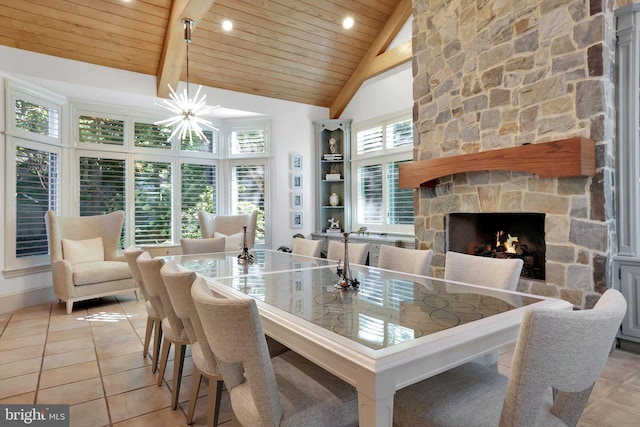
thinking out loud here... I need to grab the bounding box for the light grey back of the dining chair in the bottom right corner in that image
[500,289,627,426]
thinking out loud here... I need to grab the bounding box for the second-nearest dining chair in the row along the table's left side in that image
[160,261,224,427]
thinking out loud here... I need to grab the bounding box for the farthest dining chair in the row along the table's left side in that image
[124,246,165,372]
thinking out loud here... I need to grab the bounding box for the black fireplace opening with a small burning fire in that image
[447,213,546,280]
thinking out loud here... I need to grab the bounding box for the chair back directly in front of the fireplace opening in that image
[444,251,524,291]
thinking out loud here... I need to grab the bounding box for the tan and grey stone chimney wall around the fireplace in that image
[413,0,616,307]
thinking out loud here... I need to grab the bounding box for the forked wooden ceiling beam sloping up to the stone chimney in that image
[329,0,412,119]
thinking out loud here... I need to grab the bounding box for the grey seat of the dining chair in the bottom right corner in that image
[393,362,562,427]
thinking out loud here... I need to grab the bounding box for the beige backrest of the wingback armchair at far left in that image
[44,210,124,262]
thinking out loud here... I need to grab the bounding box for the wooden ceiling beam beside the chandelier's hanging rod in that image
[156,0,215,98]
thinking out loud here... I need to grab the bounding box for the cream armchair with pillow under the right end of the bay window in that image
[198,210,258,251]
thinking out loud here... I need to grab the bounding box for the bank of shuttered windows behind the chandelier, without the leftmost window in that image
[74,104,268,245]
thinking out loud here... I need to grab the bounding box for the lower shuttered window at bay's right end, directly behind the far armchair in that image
[231,164,266,242]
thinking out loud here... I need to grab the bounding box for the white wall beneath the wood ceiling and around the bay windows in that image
[0,17,413,313]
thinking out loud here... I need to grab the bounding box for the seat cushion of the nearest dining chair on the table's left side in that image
[231,351,358,427]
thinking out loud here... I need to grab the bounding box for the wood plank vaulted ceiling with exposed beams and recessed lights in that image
[0,0,411,117]
